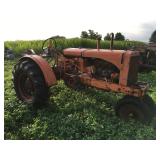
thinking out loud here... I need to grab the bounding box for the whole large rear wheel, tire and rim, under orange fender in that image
[13,60,49,104]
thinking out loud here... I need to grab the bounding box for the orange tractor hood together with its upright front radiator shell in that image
[64,48,139,86]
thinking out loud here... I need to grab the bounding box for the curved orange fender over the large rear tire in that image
[19,55,57,87]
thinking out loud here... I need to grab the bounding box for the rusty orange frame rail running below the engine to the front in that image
[64,73,149,97]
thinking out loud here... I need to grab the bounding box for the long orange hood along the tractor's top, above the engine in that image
[63,48,139,74]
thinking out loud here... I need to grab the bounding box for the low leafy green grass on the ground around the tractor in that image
[4,60,156,140]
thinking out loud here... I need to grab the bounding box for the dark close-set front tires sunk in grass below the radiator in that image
[115,95,154,122]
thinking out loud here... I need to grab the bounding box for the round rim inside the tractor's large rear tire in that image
[18,74,34,102]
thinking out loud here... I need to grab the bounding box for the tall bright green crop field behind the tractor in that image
[4,38,145,56]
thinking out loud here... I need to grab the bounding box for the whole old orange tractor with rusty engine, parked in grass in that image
[13,36,156,122]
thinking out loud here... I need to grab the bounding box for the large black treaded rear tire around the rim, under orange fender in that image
[12,60,49,105]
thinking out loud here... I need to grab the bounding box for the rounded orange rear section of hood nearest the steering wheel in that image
[63,48,87,57]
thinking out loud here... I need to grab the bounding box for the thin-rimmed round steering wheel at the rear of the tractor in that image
[42,37,57,56]
